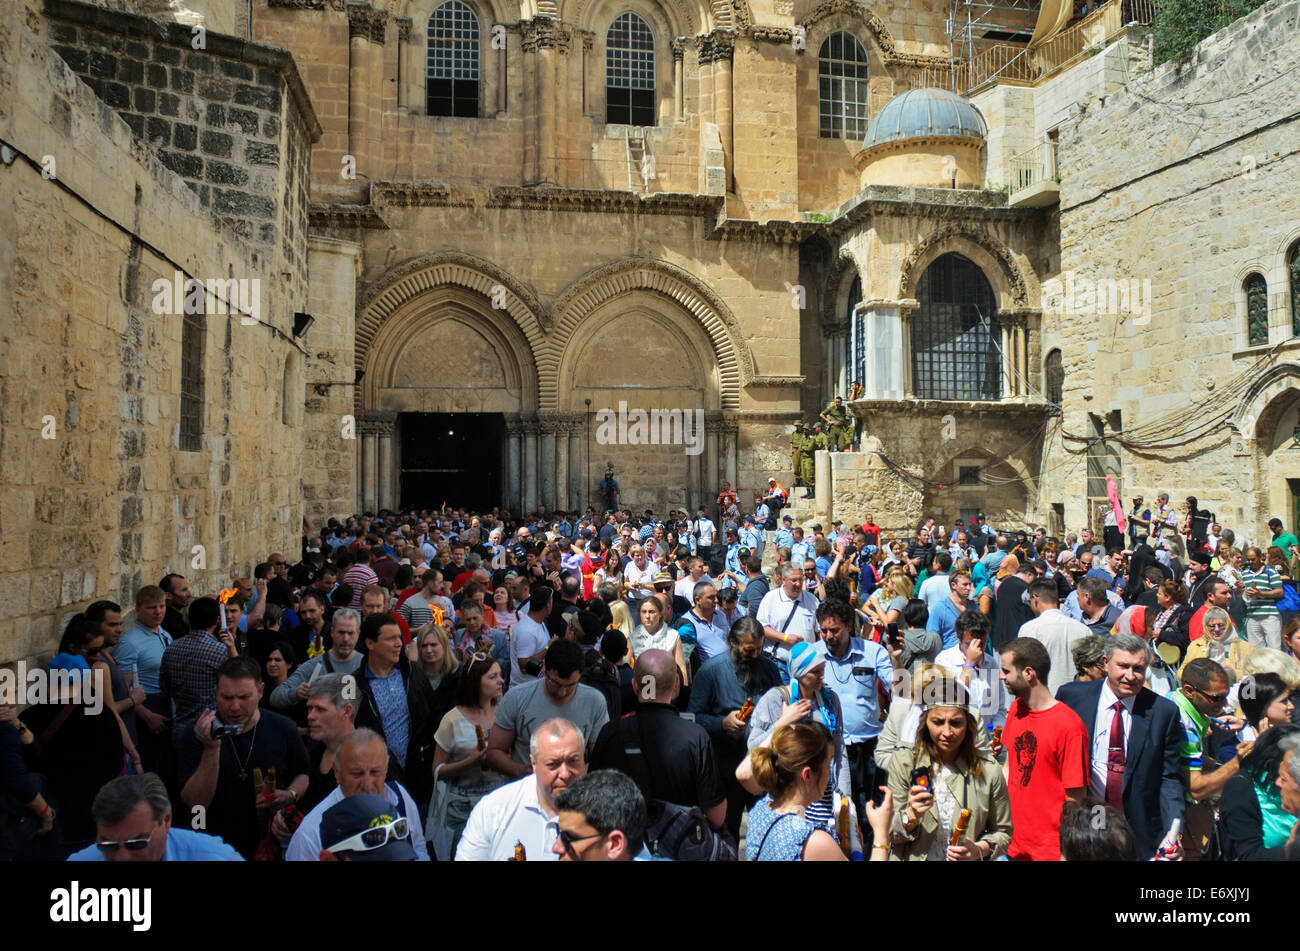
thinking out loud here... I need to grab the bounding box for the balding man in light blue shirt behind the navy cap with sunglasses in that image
[285,729,429,861]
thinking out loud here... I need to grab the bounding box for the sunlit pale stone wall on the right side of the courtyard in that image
[1041,0,1300,539]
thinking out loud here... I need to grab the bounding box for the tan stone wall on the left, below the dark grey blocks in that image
[0,4,306,663]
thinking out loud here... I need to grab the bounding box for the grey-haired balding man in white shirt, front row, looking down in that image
[452,717,586,861]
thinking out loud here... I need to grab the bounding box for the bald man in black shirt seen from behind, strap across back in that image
[592,650,727,829]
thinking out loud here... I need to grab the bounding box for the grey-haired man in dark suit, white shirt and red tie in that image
[1057,634,1184,859]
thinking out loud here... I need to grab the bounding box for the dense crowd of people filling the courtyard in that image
[0,491,1300,861]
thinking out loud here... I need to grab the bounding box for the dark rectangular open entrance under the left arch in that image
[398,413,506,511]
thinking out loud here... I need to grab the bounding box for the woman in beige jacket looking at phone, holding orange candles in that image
[888,678,1011,861]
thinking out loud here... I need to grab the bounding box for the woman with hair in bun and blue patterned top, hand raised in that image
[745,722,893,861]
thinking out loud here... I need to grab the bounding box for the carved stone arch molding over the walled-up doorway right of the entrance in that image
[537,257,754,409]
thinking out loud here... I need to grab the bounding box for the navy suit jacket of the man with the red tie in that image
[1057,681,1184,860]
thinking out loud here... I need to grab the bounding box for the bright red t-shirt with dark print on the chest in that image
[1002,698,1089,861]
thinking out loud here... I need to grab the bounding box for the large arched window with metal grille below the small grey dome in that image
[911,253,1002,400]
